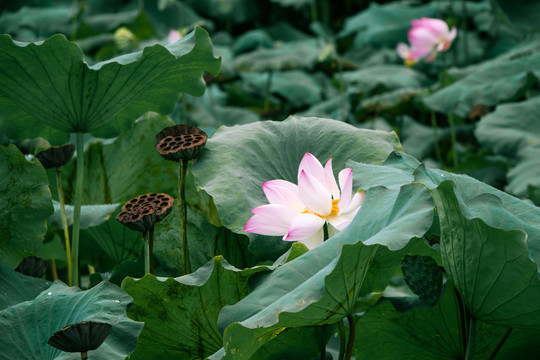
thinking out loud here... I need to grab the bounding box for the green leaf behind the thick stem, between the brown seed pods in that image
[58,113,178,204]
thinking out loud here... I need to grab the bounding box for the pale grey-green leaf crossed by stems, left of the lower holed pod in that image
[49,200,120,229]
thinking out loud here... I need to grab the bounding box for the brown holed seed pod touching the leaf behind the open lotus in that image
[156,125,208,161]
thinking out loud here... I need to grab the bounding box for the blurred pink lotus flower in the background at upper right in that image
[397,18,457,65]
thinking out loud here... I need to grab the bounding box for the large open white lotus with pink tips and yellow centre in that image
[244,153,365,249]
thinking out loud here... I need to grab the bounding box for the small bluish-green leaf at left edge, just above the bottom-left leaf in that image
[0,263,51,311]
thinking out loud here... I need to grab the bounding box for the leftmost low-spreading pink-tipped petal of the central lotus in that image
[244,204,298,236]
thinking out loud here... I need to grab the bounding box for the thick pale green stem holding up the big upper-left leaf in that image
[71,132,84,286]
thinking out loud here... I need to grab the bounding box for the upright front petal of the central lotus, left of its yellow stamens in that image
[298,170,332,216]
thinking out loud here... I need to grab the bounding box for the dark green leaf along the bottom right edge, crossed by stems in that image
[353,282,540,360]
